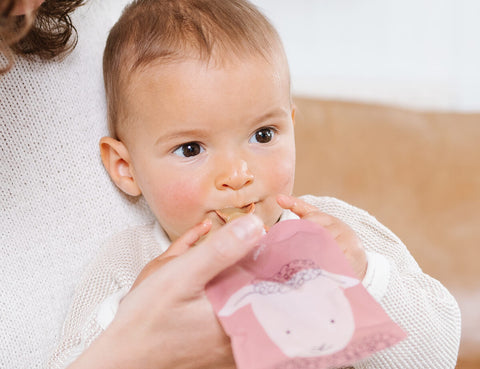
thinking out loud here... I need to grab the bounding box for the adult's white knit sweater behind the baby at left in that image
[0,0,152,369]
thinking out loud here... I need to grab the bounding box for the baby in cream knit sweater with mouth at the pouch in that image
[48,0,460,368]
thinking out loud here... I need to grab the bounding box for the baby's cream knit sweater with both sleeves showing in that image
[49,196,460,369]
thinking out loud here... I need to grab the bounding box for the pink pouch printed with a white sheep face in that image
[206,220,406,369]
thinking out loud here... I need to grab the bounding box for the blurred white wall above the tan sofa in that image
[253,0,480,111]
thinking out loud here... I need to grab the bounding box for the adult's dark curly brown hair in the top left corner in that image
[0,0,85,74]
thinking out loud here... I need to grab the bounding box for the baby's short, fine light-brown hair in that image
[103,0,284,137]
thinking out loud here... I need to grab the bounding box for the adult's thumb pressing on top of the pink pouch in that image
[173,215,264,290]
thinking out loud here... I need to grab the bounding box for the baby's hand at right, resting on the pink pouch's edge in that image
[277,195,367,280]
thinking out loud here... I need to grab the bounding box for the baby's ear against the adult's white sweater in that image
[100,137,142,196]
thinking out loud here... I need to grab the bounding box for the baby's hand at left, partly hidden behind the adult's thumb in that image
[131,219,212,290]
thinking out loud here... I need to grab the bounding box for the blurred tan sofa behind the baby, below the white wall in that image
[295,98,480,369]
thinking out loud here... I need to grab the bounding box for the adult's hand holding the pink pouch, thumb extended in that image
[70,215,263,369]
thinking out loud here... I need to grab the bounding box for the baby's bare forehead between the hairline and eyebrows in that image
[119,51,291,137]
